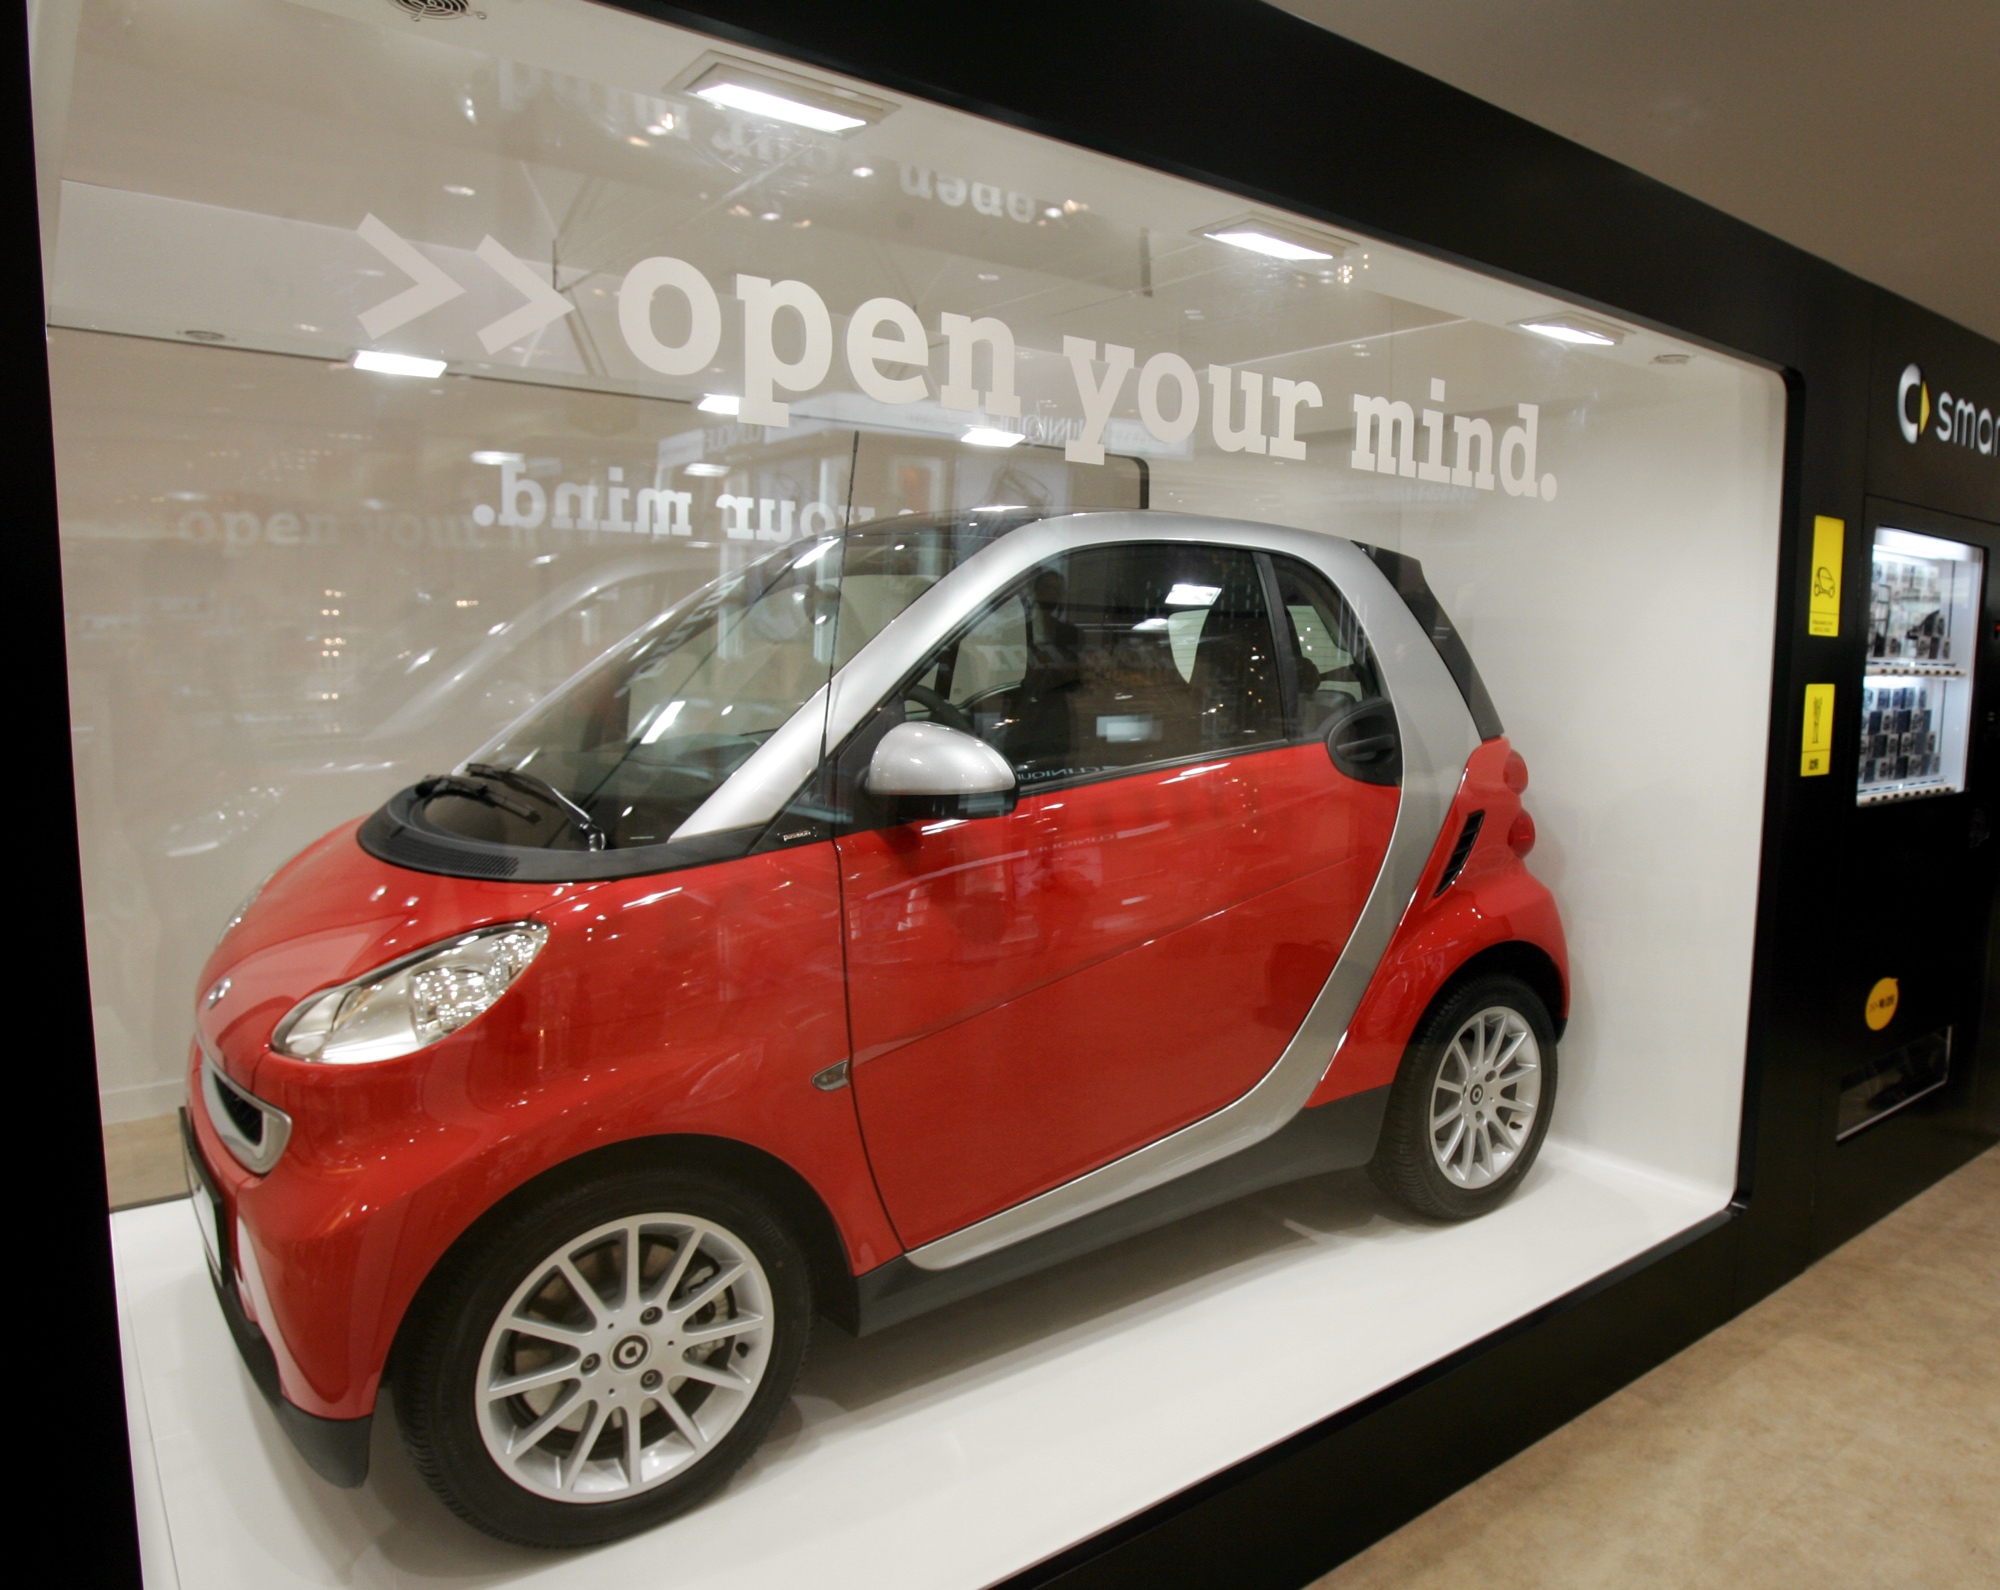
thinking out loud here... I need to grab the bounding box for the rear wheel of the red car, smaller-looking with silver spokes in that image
[1368,974,1556,1220]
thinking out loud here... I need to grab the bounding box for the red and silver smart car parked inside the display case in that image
[188,510,1566,1546]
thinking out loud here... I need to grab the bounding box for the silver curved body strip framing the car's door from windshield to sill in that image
[676,510,1480,1270]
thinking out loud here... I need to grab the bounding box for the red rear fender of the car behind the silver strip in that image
[1306,736,1570,1108]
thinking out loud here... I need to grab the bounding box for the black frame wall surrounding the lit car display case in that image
[27,0,2000,1590]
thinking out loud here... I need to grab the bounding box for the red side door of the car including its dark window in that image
[838,542,1396,1246]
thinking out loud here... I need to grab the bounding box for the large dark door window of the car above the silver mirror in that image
[904,544,1284,792]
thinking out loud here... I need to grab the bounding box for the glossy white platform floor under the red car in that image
[112,1142,1728,1590]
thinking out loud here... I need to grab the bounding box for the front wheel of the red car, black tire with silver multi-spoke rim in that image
[394,1170,814,1548]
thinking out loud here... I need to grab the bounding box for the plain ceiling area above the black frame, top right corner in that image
[1278,0,2000,338]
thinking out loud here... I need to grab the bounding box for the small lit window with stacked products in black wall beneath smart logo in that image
[1856,526,1986,806]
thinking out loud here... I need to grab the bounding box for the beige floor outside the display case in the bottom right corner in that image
[1312,1150,2000,1590]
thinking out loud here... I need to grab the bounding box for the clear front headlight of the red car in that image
[270,922,548,1066]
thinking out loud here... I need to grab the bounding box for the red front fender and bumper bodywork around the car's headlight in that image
[194,834,900,1418]
